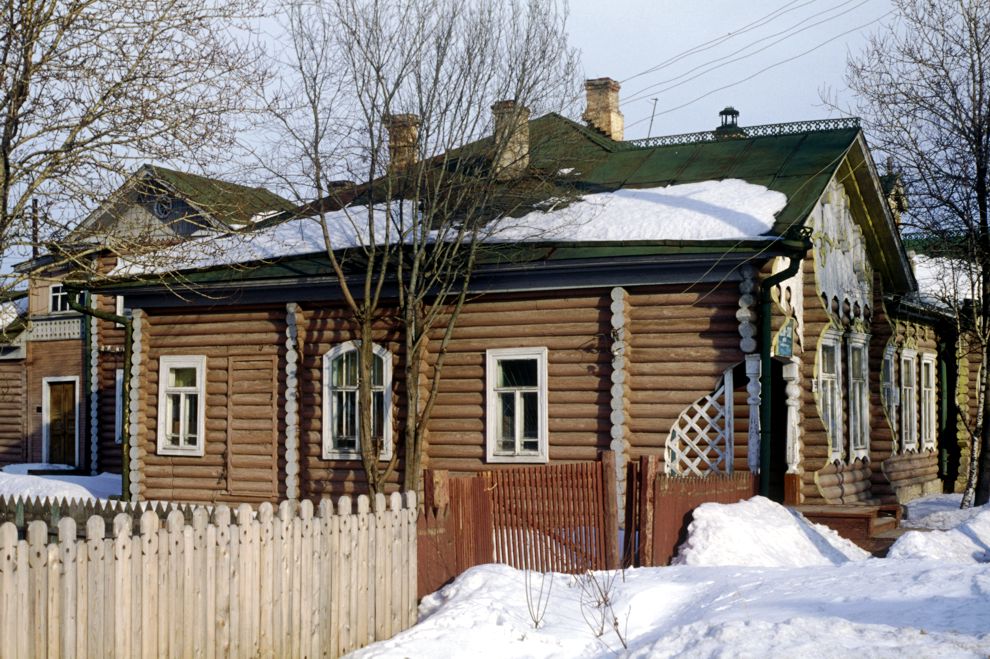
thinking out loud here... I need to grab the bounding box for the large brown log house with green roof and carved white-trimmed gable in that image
[104,79,964,504]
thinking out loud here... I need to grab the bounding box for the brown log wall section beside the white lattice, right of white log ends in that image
[627,282,748,469]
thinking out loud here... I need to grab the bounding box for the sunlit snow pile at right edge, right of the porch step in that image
[887,510,990,563]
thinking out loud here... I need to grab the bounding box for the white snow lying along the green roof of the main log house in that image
[112,179,787,276]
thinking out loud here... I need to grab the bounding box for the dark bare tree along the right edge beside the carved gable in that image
[847,0,990,504]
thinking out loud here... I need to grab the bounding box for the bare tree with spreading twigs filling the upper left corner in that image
[0,0,263,288]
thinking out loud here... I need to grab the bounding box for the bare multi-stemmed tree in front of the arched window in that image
[268,0,578,492]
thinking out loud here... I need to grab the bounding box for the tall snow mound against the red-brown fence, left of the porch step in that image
[674,497,869,567]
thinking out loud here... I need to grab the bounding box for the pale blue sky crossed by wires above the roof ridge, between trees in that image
[569,0,891,139]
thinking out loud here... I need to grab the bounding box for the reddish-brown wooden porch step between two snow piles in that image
[791,504,902,556]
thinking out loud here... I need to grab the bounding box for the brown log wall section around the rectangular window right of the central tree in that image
[424,289,612,475]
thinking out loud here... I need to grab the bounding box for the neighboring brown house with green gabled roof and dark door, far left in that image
[0,165,292,472]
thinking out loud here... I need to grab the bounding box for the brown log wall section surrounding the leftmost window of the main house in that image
[139,307,285,502]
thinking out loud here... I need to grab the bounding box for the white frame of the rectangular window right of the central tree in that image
[485,347,550,464]
